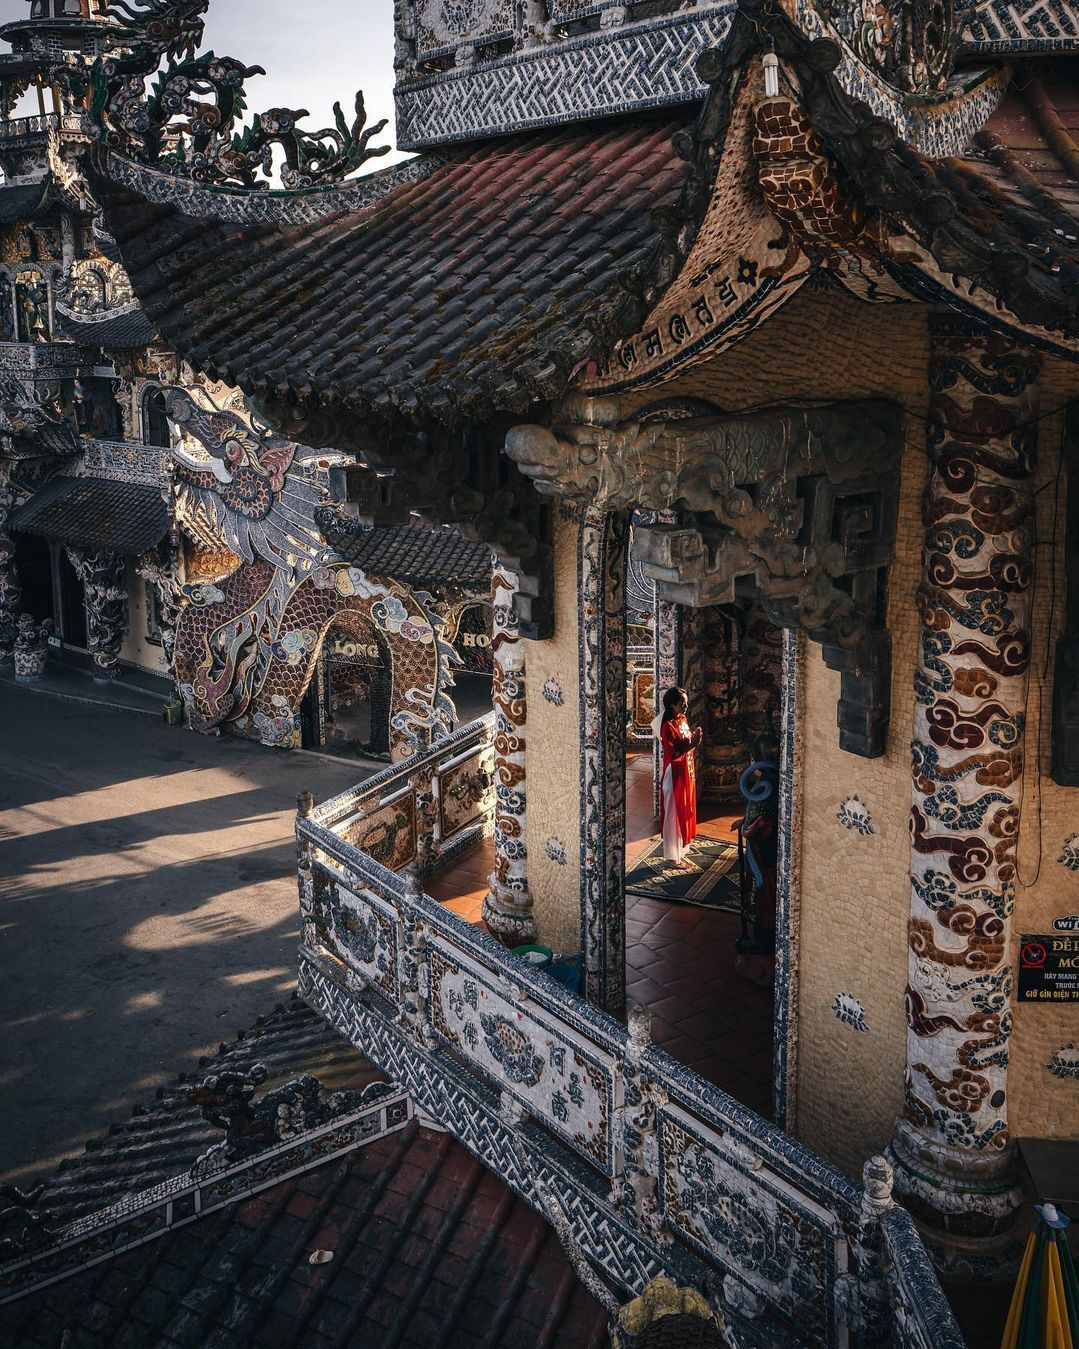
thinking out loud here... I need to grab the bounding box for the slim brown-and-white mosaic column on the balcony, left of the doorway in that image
[483,565,537,946]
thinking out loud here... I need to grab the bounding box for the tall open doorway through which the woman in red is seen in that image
[626,603,782,1116]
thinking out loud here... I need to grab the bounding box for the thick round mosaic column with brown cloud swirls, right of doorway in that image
[892,317,1039,1272]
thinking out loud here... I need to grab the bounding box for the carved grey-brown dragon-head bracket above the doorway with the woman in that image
[506,399,902,757]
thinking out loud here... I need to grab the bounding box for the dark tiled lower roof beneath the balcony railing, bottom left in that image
[0,998,608,1349]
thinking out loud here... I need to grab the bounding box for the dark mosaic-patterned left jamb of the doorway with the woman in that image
[577,506,630,1016]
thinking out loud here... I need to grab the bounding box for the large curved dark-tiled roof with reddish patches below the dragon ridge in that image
[97,109,696,417]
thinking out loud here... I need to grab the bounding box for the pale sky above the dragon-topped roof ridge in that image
[0,0,402,169]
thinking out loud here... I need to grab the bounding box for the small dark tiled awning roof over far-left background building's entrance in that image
[8,475,169,556]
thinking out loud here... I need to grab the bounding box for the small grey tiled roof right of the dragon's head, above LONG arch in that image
[316,507,492,590]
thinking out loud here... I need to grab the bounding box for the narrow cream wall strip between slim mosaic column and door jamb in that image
[525,507,580,954]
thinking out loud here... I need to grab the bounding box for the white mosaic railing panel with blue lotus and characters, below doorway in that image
[430,951,615,1174]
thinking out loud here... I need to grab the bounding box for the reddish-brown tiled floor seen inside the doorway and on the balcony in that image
[428,753,771,1116]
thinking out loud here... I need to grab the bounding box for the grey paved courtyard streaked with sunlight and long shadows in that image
[0,685,368,1183]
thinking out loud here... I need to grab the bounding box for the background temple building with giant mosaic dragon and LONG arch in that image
[0,3,491,758]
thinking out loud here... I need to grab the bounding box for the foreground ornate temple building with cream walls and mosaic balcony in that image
[5,0,1079,1349]
